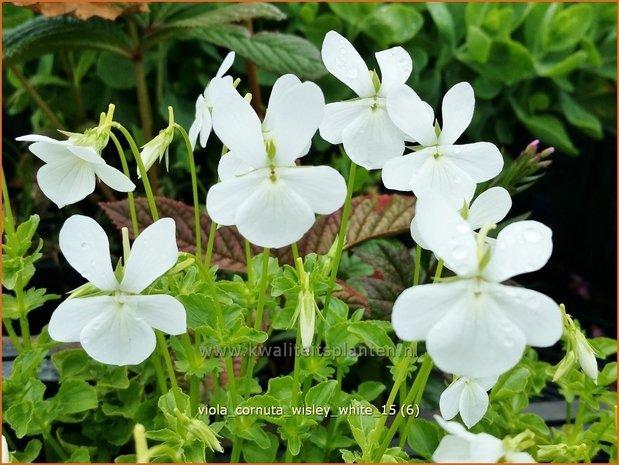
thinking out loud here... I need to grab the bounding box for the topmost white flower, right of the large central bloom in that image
[320,31,413,169]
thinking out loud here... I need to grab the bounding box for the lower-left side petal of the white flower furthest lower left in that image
[48,295,115,342]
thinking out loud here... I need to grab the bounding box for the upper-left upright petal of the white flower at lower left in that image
[58,215,118,291]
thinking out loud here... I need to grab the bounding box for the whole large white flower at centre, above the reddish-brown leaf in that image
[206,74,346,248]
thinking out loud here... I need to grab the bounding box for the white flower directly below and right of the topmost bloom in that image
[382,82,503,202]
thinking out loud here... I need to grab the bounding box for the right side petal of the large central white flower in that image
[277,166,346,215]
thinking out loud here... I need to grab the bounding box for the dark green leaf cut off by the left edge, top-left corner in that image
[3,16,130,64]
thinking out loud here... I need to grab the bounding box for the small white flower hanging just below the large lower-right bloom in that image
[439,376,498,428]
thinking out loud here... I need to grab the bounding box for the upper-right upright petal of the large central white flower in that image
[264,75,325,166]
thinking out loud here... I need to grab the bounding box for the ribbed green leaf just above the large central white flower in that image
[194,25,326,79]
